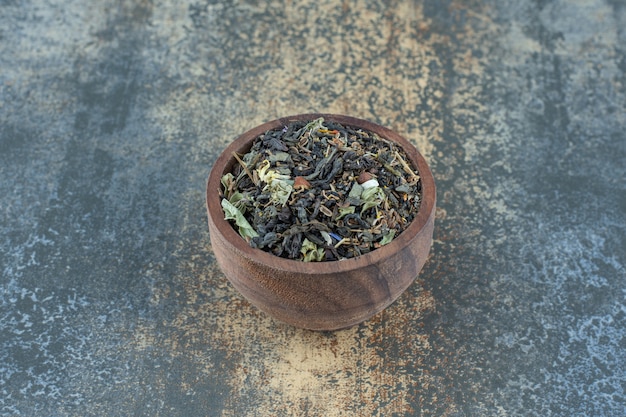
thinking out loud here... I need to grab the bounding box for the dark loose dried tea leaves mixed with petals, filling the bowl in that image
[221,118,421,261]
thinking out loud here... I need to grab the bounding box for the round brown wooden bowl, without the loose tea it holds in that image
[206,114,436,330]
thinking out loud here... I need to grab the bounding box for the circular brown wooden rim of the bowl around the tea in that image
[206,113,437,275]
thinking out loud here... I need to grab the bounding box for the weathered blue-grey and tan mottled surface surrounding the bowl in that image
[0,0,626,417]
